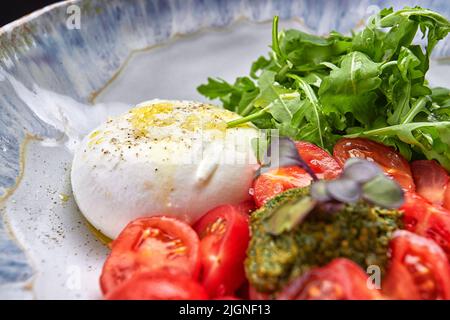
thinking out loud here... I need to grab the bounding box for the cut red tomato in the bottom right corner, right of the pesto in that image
[383,230,450,300]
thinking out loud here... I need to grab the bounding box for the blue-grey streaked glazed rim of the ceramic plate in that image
[0,0,450,292]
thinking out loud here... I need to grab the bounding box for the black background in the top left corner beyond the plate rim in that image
[0,0,59,26]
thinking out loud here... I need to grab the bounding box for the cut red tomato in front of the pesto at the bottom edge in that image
[277,258,382,300]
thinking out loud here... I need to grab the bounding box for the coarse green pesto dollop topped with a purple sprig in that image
[245,188,401,292]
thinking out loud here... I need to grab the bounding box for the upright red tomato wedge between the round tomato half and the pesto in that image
[194,205,250,297]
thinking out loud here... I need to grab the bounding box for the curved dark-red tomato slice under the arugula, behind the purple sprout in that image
[333,138,415,191]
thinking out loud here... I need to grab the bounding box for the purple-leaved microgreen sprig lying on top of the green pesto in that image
[266,149,404,235]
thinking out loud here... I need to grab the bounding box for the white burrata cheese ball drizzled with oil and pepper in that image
[71,100,258,238]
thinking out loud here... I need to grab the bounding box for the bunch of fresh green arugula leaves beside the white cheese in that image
[198,7,450,170]
